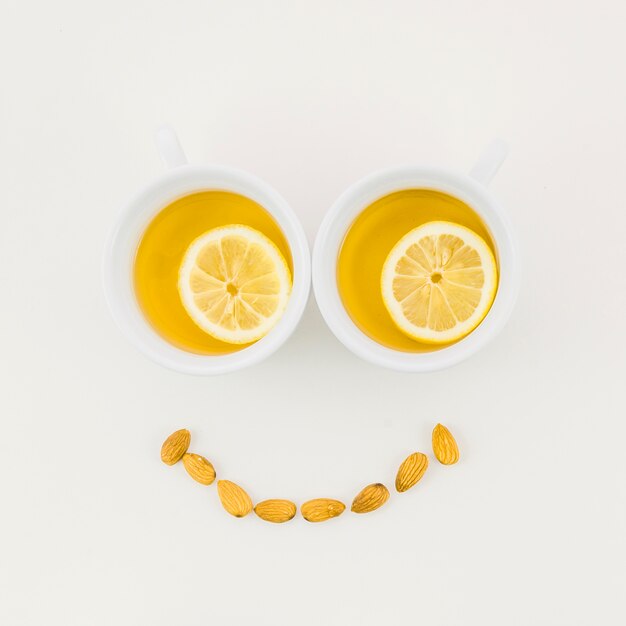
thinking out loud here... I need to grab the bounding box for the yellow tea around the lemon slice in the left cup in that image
[134,191,293,355]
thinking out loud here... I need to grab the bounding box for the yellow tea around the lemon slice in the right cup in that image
[337,189,497,352]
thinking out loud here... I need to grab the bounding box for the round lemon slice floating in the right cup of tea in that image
[381,222,498,343]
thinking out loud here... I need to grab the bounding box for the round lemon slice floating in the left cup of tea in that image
[178,224,291,344]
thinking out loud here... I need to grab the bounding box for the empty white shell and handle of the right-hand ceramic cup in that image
[313,140,520,372]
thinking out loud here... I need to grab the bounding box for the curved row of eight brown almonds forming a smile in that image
[161,424,459,524]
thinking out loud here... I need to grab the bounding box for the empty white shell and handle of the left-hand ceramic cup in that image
[103,126,311,374]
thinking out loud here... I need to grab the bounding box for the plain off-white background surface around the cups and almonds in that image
[0,0,626,626]
